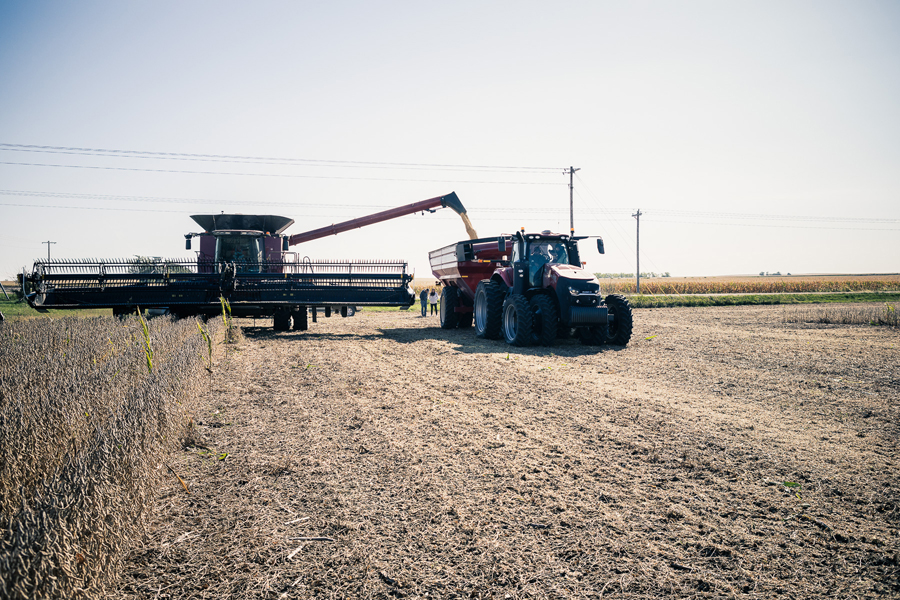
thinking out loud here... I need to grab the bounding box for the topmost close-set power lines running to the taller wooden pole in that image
[0,143,559,173]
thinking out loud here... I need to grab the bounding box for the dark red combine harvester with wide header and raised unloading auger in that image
[21,192,465,331]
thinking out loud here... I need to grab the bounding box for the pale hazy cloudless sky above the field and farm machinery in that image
[0,0,900,277]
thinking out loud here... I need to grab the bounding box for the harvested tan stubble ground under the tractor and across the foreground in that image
[119,307,900,598]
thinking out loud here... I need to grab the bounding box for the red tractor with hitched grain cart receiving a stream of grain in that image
[429,229,632,346]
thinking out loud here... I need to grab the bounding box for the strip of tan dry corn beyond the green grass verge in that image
[600,278,900,294]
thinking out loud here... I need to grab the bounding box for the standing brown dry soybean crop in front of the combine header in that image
[0,317,219,599]
